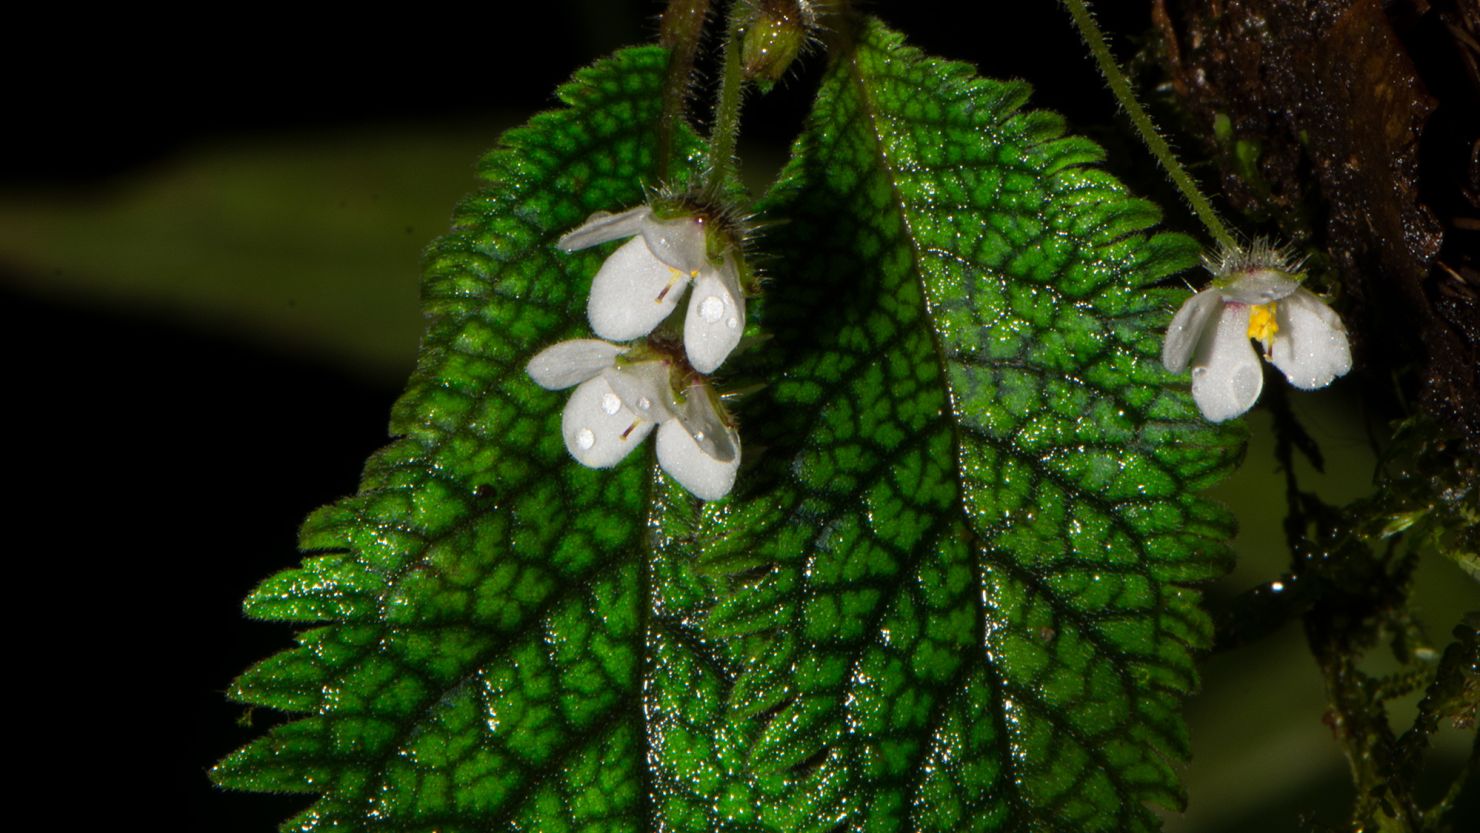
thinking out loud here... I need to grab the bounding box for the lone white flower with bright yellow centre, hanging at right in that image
[1162,268,1351,422]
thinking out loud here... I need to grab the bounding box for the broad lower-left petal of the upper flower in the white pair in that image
[586,237,688,342]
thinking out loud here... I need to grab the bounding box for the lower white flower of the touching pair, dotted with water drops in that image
[525,339,740,500]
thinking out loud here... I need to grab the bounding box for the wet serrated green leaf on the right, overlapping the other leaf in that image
[703,22,1240,832]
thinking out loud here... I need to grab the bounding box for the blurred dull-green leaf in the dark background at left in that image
[0,121,509,383]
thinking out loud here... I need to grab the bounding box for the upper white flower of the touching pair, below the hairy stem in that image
[559,206,744,373]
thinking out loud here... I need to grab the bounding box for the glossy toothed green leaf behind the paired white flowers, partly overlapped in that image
[213,47,764,833]
